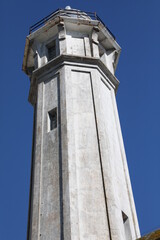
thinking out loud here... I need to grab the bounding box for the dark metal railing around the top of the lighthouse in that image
[29,9,115,39]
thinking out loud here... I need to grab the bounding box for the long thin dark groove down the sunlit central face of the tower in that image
[90,74,112,240]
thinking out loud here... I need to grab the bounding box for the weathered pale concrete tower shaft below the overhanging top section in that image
[27,62,139,240]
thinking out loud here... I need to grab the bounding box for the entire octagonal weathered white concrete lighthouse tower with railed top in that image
[23,7,140,240]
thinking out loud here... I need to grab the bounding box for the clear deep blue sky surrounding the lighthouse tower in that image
[0,0,160,240]
